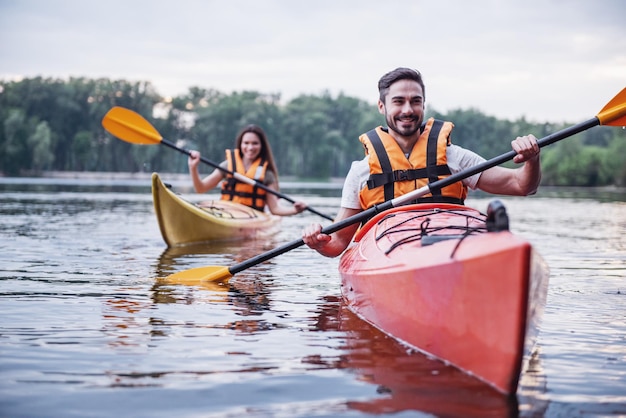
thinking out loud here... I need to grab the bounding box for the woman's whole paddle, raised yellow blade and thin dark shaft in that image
[102,106,333,221]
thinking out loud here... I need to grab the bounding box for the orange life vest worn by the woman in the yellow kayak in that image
[222,150,267,211]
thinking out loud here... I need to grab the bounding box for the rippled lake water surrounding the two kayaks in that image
[0,175,626,417]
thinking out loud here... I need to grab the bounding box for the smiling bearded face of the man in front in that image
[378,80,424,137]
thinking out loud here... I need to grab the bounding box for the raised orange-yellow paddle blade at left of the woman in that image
[102,106,163,145]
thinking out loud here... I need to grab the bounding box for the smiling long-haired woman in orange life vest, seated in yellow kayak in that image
[187,125,306,216]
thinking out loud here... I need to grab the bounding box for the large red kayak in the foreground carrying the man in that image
[339,201,549,394]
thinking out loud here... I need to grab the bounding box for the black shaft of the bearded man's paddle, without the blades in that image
[228,117,600,275]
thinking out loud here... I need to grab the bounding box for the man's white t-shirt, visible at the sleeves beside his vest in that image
[341,144,486,209]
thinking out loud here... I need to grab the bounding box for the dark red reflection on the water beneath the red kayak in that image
[303,297,518,418]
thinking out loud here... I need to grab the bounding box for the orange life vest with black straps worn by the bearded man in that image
[359,118,467,209]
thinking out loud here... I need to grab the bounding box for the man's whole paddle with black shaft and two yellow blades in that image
[169,88,626,281]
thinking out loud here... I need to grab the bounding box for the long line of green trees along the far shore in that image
[0,77,626,186]
